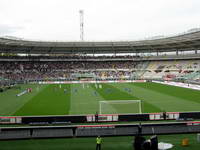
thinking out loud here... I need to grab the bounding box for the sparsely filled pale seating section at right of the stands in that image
[143,60,200,80]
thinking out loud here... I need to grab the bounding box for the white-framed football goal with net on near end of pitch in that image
[99,100,142,114]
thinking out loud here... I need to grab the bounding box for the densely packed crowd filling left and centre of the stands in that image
[0,61,141,80]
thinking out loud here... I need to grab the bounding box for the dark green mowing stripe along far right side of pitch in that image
[134,82,200,103]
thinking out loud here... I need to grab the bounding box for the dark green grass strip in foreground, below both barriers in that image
[0,134,200,150]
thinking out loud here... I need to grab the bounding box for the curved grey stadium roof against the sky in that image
[0,31,200,54]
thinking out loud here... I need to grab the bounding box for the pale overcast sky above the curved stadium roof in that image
[0,0,200,41]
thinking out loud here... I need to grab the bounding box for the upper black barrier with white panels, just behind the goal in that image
[0,112,200,125]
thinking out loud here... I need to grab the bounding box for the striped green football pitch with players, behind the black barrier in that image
[0,82,200,116]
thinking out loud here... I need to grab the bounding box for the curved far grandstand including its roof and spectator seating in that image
[0,30,200,83]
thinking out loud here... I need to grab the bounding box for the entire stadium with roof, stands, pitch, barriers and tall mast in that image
[0,0,200,150]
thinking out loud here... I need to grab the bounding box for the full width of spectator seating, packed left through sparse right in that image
[0,60,200,81]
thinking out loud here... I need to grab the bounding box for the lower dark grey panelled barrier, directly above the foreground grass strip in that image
[0,122,200,140]
